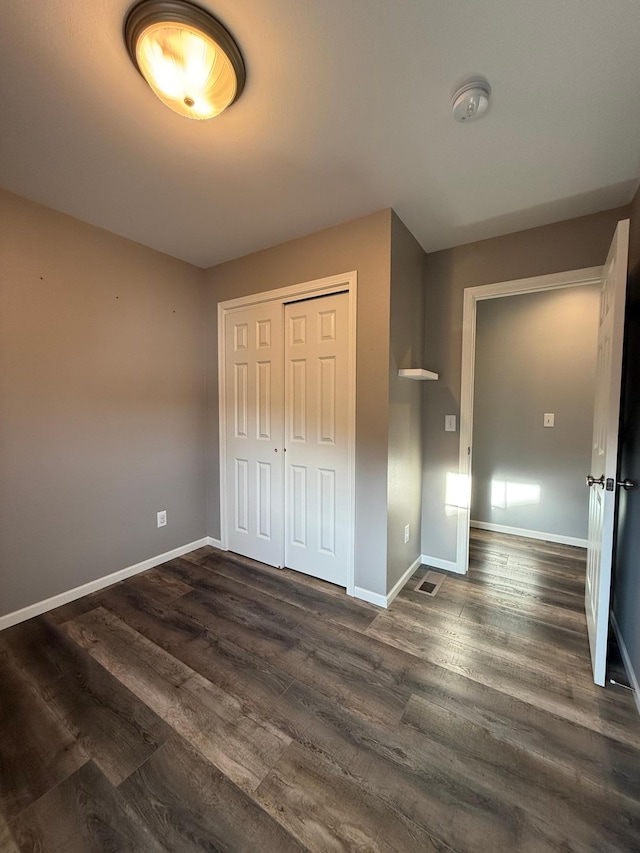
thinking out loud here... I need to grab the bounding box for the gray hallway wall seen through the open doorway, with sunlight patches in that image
[471,286,600,539]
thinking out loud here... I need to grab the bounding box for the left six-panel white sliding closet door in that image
[225,302,284,566]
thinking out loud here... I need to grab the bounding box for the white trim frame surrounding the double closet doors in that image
[218,271,358,595]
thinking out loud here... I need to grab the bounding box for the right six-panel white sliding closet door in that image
[285,293,349,586]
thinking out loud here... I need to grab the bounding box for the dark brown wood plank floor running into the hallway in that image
[0,530,640,853]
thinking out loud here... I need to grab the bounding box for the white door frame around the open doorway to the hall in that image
[456,267,604,574]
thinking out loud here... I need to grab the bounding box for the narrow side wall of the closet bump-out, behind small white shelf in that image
[387,213,425,591]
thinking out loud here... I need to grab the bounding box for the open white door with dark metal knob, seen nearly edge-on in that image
[585,219,629,686]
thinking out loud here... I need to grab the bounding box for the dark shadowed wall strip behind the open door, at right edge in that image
[613,181,640,692]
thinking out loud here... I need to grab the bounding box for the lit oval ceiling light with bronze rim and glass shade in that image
[124,0,246,119]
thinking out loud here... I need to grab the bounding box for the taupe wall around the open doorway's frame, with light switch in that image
[422,207,629,560]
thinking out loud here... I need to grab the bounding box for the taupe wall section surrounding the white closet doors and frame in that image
[207,210,391,595]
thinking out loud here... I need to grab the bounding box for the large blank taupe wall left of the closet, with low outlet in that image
[0,191,207,615]
